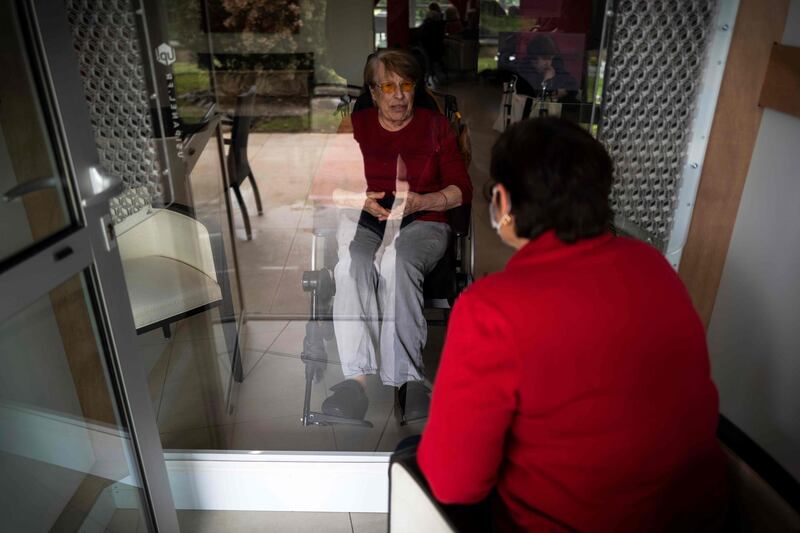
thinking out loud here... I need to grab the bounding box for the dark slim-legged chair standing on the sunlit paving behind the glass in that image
[225,85,264,241]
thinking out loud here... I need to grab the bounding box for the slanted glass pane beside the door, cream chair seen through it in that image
[62,0,244,454]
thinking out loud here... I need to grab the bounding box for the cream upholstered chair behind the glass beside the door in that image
[115,208,243,382]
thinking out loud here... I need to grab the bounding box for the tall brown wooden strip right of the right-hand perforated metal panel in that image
[679,0,789,327]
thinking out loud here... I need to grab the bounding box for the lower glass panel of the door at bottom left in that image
[0,277,148,532]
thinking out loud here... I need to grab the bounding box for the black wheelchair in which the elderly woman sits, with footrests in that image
[301,89,475,427]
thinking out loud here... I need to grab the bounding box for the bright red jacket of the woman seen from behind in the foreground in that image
[418,232,725,531]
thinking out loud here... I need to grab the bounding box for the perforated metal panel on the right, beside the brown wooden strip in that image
[599,0,716,250]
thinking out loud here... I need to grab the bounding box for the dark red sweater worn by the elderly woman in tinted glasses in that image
[353,107,472,222]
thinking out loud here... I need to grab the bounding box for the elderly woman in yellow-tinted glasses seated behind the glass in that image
[304,50,472,423]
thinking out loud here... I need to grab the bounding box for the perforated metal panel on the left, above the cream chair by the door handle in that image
[66,0,163,222]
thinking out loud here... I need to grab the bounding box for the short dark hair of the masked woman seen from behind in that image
[491,117,614,243]
